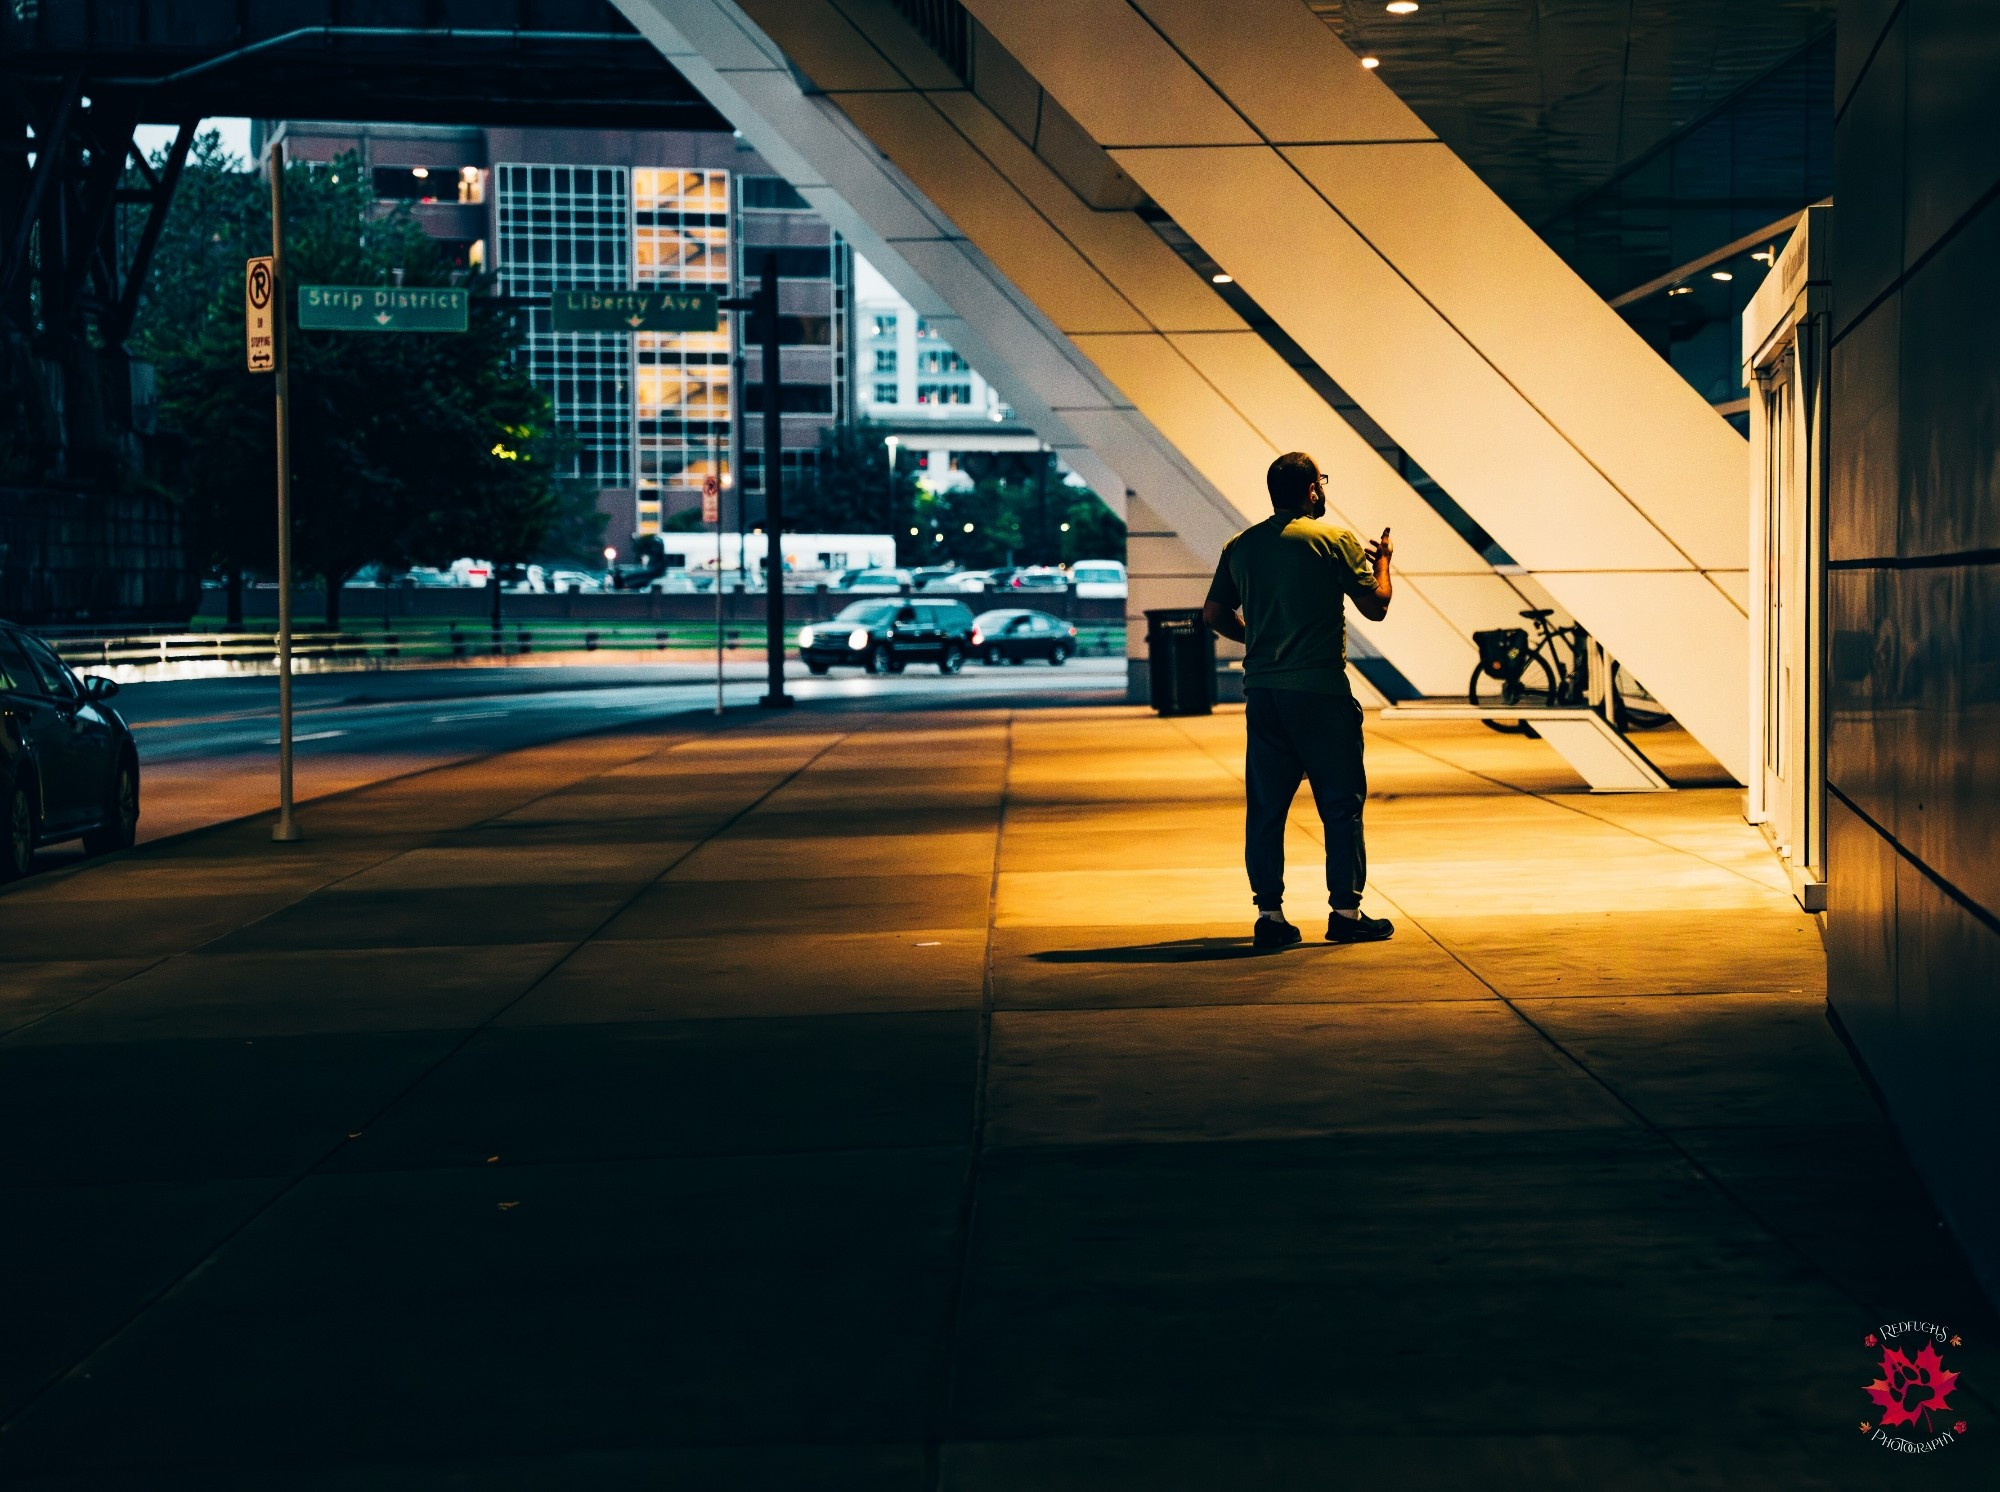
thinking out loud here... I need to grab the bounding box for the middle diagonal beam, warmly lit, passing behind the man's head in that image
[616,0,1528,694]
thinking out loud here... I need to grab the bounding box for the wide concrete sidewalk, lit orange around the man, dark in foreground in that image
[0,708,1996,1492]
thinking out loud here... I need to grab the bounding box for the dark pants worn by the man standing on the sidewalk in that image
[1244,688,1368,910]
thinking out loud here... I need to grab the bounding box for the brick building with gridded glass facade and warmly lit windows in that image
[252,120,848,550]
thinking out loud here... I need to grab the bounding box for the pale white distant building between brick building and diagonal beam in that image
[854,254,1040,490]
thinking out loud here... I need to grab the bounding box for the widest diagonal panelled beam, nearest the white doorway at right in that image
[966,0,1750,778]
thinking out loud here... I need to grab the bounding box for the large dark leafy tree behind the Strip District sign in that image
[148,156,602,626]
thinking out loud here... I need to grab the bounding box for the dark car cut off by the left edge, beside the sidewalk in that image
[0,622,138,880]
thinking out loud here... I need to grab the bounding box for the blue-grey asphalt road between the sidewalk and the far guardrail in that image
[36,658,1124,866]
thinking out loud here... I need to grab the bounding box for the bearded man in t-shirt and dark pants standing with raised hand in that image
[1202,450,1396,948]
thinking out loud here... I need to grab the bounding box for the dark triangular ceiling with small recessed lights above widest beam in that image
[1306,0,1836,224]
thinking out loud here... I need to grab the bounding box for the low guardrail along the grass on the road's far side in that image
[44,622,1124,682]
